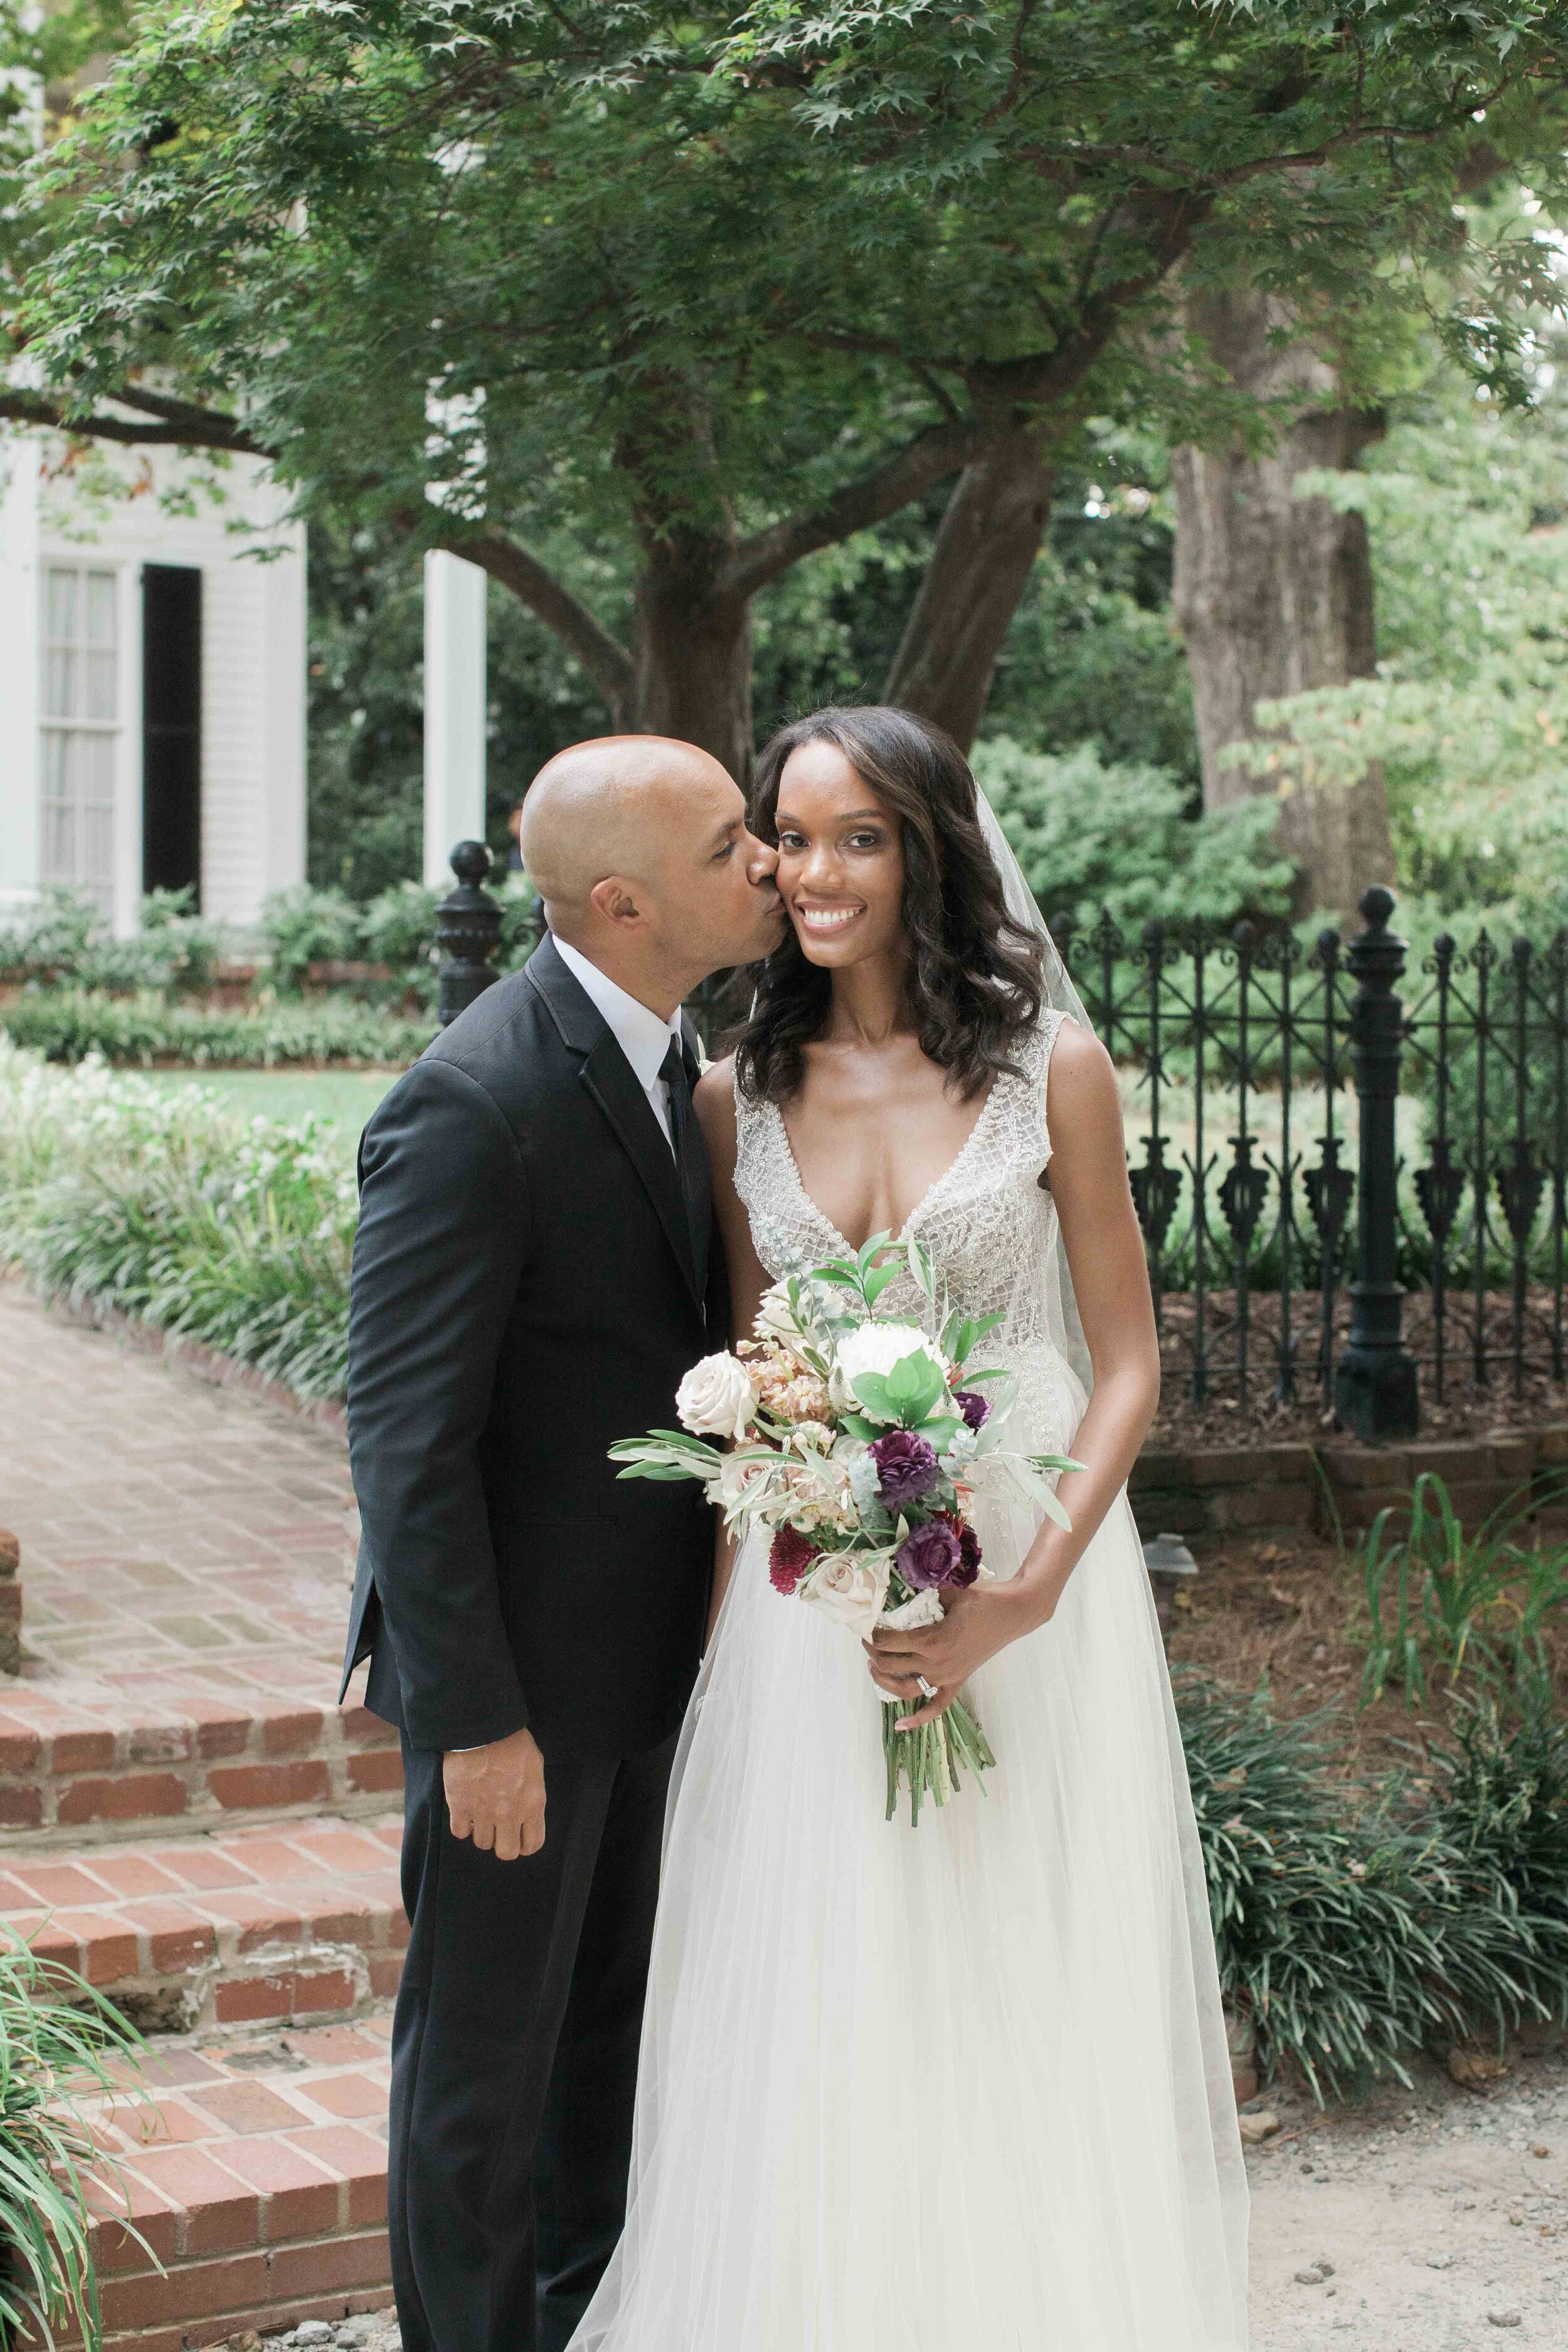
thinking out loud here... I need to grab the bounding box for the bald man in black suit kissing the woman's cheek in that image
[348,736,783,2352]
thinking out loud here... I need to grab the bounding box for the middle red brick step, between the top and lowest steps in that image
[0,1818,409,2032]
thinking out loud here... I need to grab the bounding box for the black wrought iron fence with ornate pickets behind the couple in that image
[442,844,1568,1437]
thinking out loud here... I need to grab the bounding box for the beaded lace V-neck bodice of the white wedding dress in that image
[736,1014,1065,1348]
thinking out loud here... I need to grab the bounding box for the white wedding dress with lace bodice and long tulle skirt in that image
[571,1016,1246,2352]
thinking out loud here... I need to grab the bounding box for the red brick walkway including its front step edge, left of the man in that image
[0,1282,400,1841]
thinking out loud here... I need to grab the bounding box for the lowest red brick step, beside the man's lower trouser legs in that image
[64,2016,390,2352]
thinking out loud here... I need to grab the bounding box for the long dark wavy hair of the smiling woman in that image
[736,703,1044,1103]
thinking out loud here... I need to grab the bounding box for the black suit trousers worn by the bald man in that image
[388,1740,675,2352]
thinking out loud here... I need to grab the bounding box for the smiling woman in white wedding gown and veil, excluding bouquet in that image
[571,708,1246,2352]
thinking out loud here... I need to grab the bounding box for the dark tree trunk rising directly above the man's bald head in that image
[630,539,752,790]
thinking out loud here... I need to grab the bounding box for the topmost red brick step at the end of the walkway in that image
[0,1680,402,1851]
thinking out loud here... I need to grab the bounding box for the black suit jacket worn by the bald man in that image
[343,938,726,1755]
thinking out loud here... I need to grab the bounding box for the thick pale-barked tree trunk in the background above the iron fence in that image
[1171,289,1394,915]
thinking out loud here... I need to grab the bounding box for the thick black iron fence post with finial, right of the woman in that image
[1333,884,1420,1439]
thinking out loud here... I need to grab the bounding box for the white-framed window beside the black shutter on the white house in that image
[42,564,120,908]
